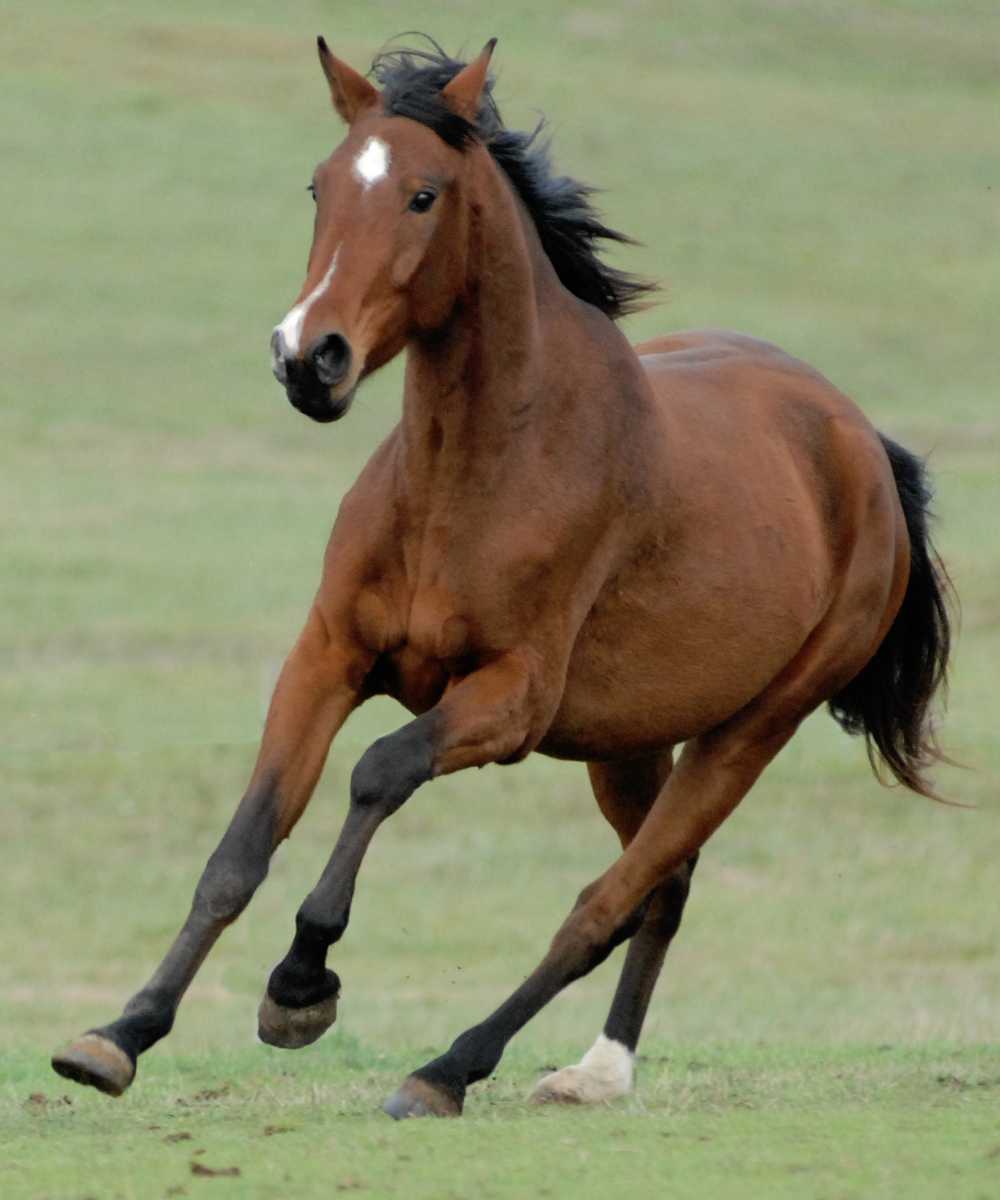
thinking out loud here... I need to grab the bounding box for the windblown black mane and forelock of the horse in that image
[370,35,655,319]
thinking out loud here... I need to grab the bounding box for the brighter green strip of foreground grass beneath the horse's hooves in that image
[7,1036,1000,1200]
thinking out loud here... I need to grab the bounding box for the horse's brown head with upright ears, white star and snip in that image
[271,37,493,421]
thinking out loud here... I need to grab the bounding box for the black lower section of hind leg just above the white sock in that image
[604,854,697,1051]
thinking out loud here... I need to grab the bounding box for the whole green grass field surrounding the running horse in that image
[0,0,1000,1200]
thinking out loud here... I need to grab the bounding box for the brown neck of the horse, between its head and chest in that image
[401,154,583,482]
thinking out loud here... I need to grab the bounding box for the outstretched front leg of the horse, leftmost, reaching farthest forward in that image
[52,610,367,1096]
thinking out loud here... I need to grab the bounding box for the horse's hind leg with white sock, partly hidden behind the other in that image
[531,751,697,1104]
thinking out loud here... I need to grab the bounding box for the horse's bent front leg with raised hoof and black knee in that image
[259,653,534,1049]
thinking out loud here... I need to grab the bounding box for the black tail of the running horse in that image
[830,437,951,799]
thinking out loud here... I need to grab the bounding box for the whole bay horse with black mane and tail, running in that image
[53,38,950,1117]
